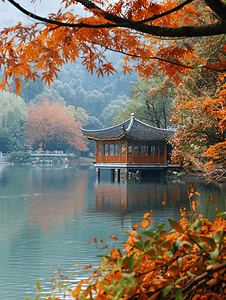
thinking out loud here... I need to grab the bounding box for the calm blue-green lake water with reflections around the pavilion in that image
[0,165,226,300]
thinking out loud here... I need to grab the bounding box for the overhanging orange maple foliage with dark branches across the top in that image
[0,0,226,91]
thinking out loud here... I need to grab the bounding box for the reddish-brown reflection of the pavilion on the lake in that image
[95,182,183,212]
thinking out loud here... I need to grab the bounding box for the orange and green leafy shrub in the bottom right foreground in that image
[32,207,226,300]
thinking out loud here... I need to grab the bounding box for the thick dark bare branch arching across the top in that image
[8,0,226,37]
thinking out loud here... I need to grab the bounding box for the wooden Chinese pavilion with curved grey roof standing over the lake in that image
[80,114,178,180]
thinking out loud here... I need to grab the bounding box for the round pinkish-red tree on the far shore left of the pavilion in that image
[25,100,87,151]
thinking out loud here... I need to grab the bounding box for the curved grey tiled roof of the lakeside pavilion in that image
[80,116,174,141]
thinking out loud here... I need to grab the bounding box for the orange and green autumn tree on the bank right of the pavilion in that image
[171,37,225,180]
